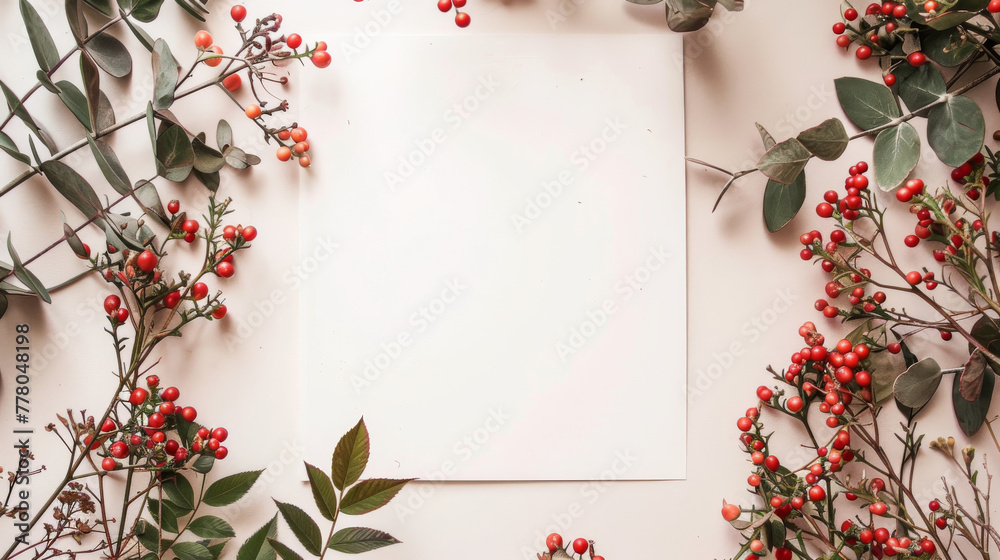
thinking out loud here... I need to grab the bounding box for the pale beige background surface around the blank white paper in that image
[0,0,988,560]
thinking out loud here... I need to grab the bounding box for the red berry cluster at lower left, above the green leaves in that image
[91,375,229,471]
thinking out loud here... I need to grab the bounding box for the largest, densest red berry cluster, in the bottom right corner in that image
[722,322,947,559]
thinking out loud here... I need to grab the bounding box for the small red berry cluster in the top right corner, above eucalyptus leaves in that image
[833,0,924,87]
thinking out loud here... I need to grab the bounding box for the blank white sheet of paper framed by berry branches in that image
[299,33,686,480]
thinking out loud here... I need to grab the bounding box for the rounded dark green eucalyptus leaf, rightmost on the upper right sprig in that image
[927,96,986,167]
